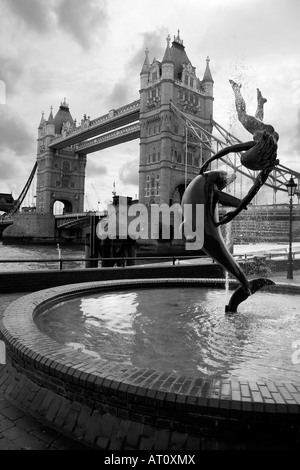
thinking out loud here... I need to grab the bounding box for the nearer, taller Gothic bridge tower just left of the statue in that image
[139,31,214,205]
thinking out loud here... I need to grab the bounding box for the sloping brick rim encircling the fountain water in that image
[0,278,300,414]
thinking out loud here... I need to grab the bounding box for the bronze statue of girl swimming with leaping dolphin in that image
[181,80,279,313]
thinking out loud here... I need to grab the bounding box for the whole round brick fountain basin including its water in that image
[0,279,300,450]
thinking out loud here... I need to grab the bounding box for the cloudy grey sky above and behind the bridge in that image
[0,0,300,210]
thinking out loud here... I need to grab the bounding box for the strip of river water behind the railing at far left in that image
[0,242,84,272]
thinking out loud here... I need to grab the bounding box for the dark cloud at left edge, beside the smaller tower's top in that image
[0,105,36,157]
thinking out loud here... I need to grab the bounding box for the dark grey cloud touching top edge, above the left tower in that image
[56,0,108,48]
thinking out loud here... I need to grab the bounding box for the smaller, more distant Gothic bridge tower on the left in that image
[36,99,86,214]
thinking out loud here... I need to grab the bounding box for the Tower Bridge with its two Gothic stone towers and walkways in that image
[0,32,300,244]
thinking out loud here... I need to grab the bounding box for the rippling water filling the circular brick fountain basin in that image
[36,287,300,382]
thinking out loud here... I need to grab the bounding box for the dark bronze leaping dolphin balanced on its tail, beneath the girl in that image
[181,170,274,313]
